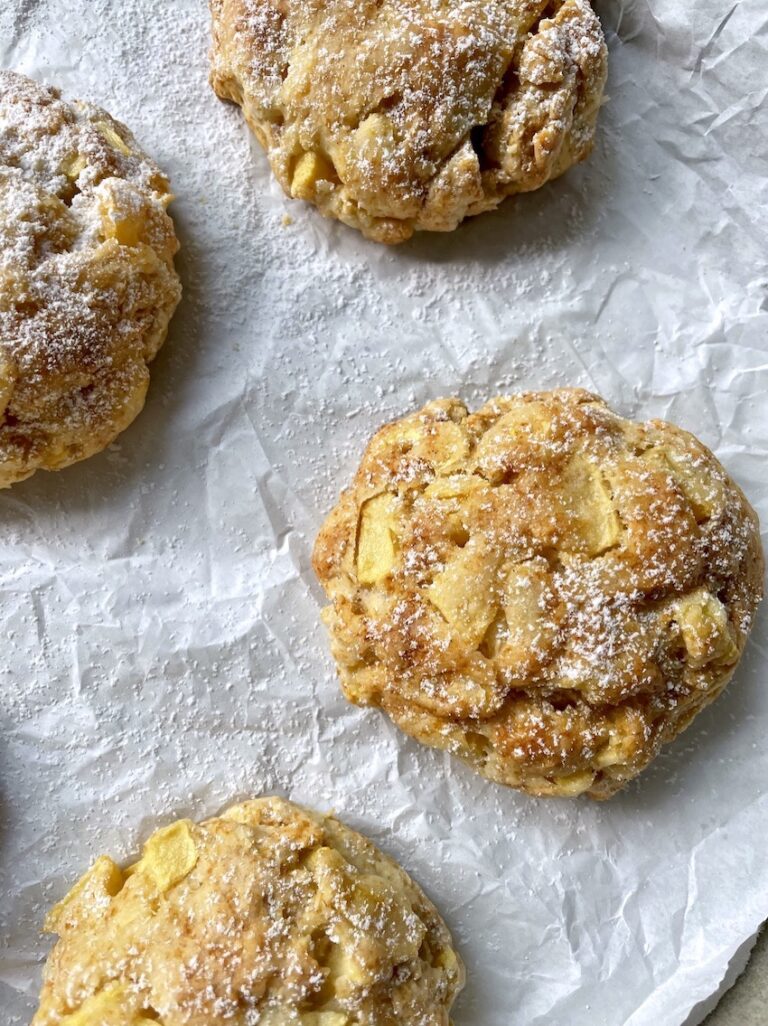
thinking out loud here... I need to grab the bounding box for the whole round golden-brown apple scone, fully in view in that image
[314,390,763,798]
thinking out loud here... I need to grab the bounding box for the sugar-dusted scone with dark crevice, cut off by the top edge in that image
[210,0,606,243]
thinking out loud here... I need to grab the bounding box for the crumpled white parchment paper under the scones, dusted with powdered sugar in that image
[0,0,768,1026]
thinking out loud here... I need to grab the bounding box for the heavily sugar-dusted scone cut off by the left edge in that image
[0,71,180,487]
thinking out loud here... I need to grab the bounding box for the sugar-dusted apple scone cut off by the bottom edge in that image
[33,798,463,1026]
